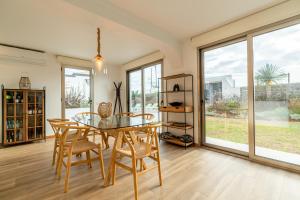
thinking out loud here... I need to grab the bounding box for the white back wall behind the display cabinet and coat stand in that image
[0,50,120,142]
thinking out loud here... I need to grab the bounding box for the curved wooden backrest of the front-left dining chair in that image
[53,122,90,145]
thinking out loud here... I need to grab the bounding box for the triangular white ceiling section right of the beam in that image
[109,0,285,39]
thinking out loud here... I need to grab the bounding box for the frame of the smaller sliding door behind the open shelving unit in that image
[126,59,164,114]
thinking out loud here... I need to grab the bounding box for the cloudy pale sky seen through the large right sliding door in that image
[204,24,300,87]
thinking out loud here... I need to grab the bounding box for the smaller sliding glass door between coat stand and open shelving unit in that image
[127,61,162,118]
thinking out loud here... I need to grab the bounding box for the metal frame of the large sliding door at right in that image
[197,15,300,173]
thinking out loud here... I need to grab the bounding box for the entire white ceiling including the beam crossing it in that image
[0,0,282,65]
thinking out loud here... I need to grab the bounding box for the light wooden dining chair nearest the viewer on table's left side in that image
[53,122,105,192]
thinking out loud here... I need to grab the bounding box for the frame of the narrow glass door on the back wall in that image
[60,65,94,118]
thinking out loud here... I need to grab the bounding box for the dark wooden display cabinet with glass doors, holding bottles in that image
[2,86,46,145]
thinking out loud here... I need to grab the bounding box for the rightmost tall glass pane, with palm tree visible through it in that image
[253,24,300,164]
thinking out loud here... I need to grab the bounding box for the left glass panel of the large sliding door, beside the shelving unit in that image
[202,39,248,152]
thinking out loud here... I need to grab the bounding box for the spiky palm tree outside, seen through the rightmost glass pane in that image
[255,63,286,86]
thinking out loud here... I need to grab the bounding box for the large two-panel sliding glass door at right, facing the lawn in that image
[201,20,300,171]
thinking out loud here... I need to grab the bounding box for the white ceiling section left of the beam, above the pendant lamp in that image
[0,0,159,65]
